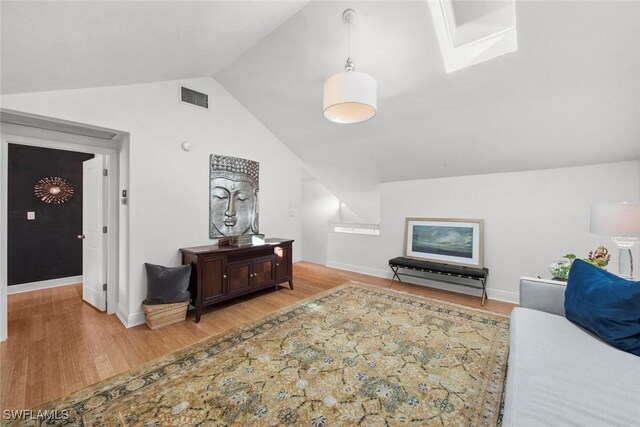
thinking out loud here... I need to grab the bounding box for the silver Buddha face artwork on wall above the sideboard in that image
[209,154,260,239]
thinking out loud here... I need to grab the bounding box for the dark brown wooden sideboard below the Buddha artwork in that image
[180,238,293,323]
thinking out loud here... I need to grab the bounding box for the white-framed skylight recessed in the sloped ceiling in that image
[427,0,518,73]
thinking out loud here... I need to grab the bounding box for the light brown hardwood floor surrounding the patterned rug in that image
[0,262,514,409]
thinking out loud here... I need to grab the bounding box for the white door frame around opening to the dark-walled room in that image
[0,110,128,341]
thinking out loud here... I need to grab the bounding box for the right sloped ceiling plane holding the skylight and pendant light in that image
[216,1,640,221]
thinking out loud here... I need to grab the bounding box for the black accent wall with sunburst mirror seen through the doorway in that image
[7,144,94,285]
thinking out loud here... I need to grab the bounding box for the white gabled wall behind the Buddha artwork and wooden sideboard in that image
[2,78,301,323]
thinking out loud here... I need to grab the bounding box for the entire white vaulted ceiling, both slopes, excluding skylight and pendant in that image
[0,0,640,221]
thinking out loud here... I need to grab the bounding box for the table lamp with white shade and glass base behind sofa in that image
[589,203,640,279]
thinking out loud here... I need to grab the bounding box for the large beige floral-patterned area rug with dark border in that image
[21,282,509,427]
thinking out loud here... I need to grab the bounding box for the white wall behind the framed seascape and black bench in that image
[328,161,640,302]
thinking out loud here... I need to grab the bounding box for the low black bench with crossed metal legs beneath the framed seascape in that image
[389,257,489,306]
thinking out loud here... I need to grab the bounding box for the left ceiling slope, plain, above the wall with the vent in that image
[0,1,306,94]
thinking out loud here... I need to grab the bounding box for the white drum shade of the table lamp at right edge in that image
[589,203,640,237]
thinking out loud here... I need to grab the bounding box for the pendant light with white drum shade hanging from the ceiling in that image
[324,9,378,123]
